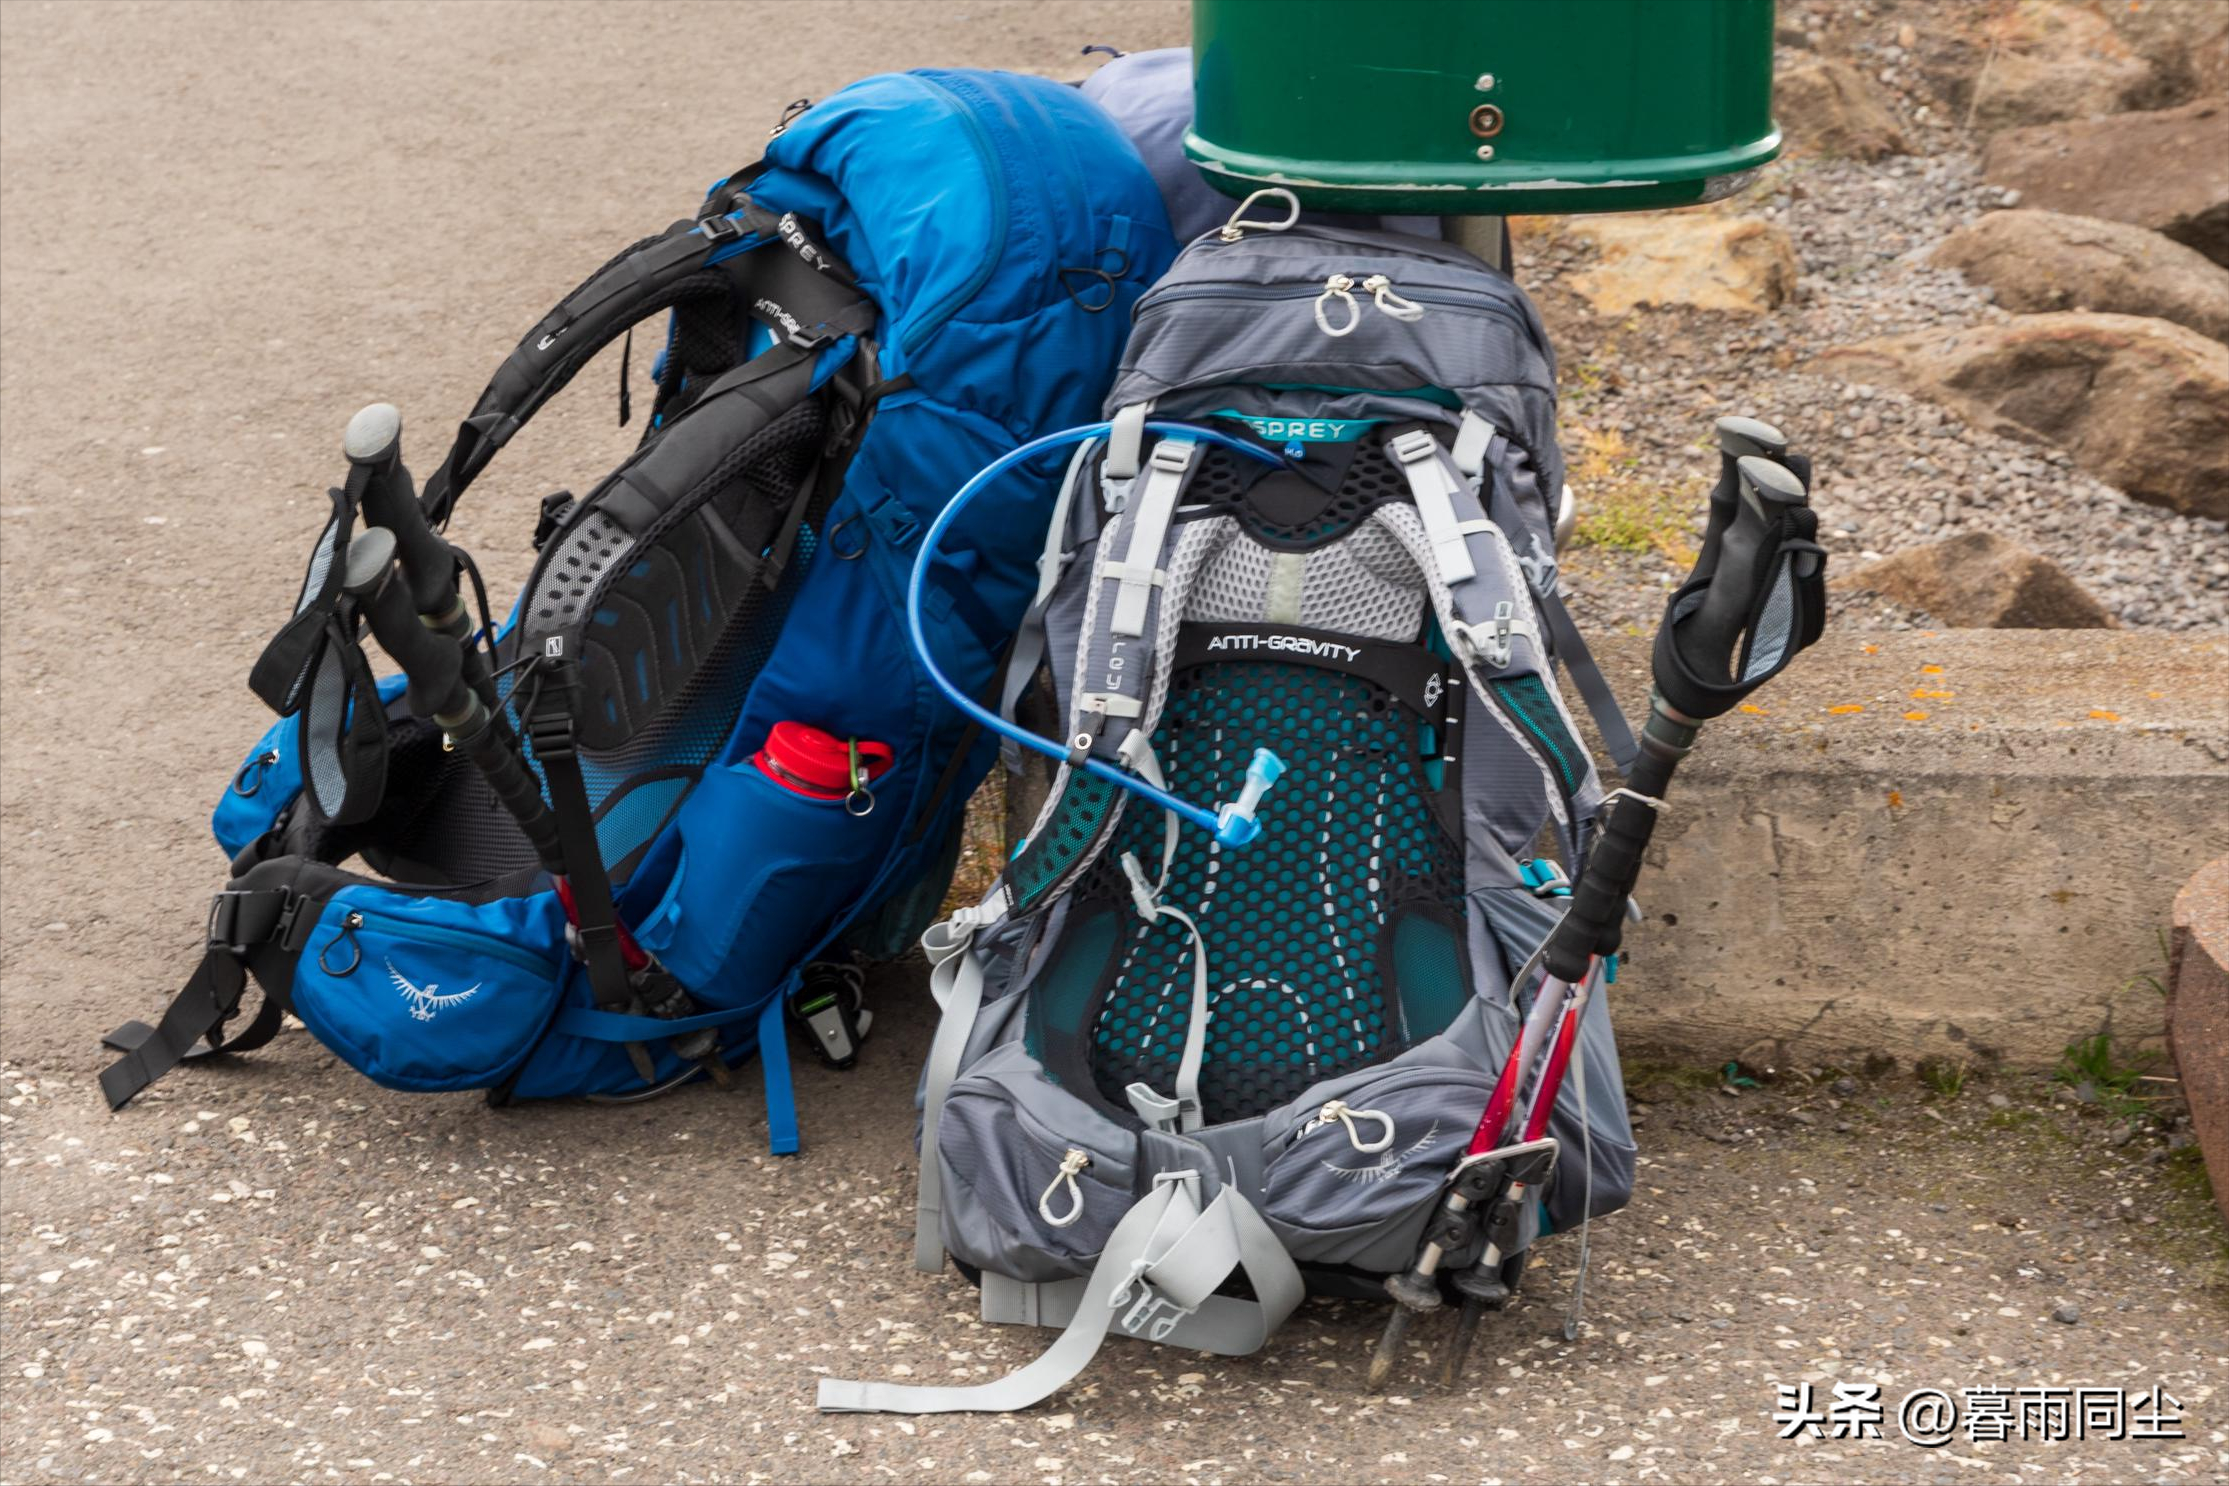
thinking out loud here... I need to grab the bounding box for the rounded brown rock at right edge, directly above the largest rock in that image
[1933,209,2229,341]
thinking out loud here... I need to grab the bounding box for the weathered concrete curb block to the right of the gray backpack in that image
[1603,630,2229,1067]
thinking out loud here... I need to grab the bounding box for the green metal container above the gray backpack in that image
[1184,0,1781,216]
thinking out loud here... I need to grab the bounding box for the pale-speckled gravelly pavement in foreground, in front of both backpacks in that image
[0,989,2229,1484]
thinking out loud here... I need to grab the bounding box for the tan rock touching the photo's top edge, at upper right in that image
[1957,0,2160,129]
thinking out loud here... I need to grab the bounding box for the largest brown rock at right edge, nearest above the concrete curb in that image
[1810,314,2229,519]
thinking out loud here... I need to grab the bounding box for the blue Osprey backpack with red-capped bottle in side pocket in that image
[103,71,1175,1152]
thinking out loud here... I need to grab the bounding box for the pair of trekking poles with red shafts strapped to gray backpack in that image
[1364,429,1826,1392]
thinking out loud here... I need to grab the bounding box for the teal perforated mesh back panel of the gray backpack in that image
[1077,662,1462,1123]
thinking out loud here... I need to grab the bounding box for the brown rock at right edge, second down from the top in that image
[1982,98,2229,265]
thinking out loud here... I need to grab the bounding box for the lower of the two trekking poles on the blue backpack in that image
[341,526,727,1083]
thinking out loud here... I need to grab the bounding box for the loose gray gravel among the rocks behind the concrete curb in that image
[1542,29,2229,630]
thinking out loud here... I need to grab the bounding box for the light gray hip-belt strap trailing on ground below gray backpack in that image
[820,1172,1304,1415]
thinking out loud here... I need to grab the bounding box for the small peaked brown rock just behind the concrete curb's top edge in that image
[1848,532,2113,628]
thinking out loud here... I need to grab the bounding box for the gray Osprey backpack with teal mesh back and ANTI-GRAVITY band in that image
[820,192,1634,1412]
